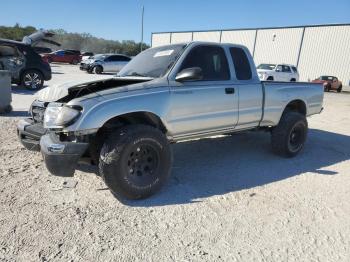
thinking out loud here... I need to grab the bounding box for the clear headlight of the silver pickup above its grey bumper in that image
[44,103,81,128]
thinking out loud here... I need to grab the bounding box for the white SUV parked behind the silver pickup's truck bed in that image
[257,64,299,82]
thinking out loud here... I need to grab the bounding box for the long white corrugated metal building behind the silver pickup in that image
[152,24,350,85]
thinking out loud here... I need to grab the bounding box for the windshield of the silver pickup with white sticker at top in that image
[118,44,186,78]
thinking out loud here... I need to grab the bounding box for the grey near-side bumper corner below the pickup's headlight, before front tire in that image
[40,133,89,176]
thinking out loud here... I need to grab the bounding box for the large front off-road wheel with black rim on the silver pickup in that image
[99,124,172,199]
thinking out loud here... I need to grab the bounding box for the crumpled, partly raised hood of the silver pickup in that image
[37,77,153,102]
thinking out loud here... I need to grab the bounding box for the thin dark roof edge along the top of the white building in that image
[151,23,350,35]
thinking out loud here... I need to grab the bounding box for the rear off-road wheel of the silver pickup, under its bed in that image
[271,111,308,157]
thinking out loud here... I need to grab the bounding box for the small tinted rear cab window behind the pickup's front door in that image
[230,47,252,80]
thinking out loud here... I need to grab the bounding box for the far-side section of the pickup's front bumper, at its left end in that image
[17,118,47,151]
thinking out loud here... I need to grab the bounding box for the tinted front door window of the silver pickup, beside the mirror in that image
[180,46,230,81]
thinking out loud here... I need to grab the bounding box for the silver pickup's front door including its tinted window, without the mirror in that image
[167,45,238,138]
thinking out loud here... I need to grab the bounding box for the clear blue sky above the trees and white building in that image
[0,0,350,44]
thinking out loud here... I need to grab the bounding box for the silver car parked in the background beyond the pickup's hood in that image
[80,54,131,74]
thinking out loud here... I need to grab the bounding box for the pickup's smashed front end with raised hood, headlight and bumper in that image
[17,77,151,176]
